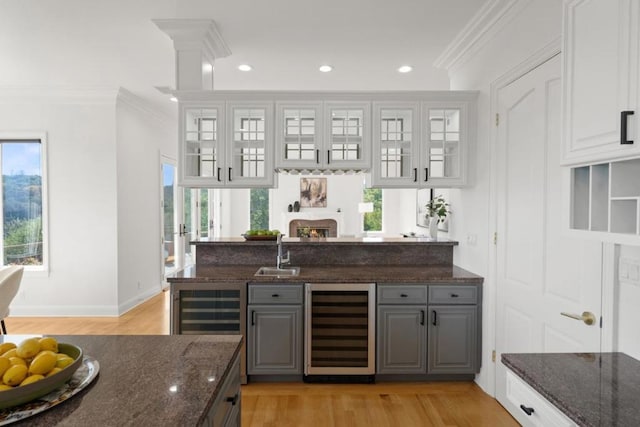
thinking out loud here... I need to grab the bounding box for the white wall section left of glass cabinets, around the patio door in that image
[116,89,178,313]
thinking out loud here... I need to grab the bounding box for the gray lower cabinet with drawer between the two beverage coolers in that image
[247,284,303,375]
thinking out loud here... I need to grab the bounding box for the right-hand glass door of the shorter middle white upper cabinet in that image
[320,101,371,169]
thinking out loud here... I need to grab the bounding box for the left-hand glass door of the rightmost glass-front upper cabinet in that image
[372,102,420,188]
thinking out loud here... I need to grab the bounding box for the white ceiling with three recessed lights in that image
[0,0,487,117]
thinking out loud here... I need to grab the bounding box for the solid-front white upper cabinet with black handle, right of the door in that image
[562,0,640,165]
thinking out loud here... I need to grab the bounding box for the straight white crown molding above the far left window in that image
[0,86,119,105]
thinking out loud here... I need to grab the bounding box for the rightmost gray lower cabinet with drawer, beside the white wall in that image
[427,286,480,374]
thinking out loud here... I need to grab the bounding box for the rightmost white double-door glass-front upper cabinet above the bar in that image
[371,98,476,188]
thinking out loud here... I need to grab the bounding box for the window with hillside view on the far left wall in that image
[0,135,47,269]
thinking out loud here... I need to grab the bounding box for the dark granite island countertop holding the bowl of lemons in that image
[5,335,242,427]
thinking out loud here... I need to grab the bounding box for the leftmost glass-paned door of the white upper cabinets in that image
[179,103,224,186]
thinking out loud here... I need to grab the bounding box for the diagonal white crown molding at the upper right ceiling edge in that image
[433,0,532,74]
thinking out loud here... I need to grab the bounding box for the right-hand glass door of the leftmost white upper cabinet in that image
[224,102,275,188]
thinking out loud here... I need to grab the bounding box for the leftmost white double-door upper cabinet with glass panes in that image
[179,101,275,188]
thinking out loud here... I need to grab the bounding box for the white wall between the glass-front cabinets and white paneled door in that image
[450,0,562,394]
